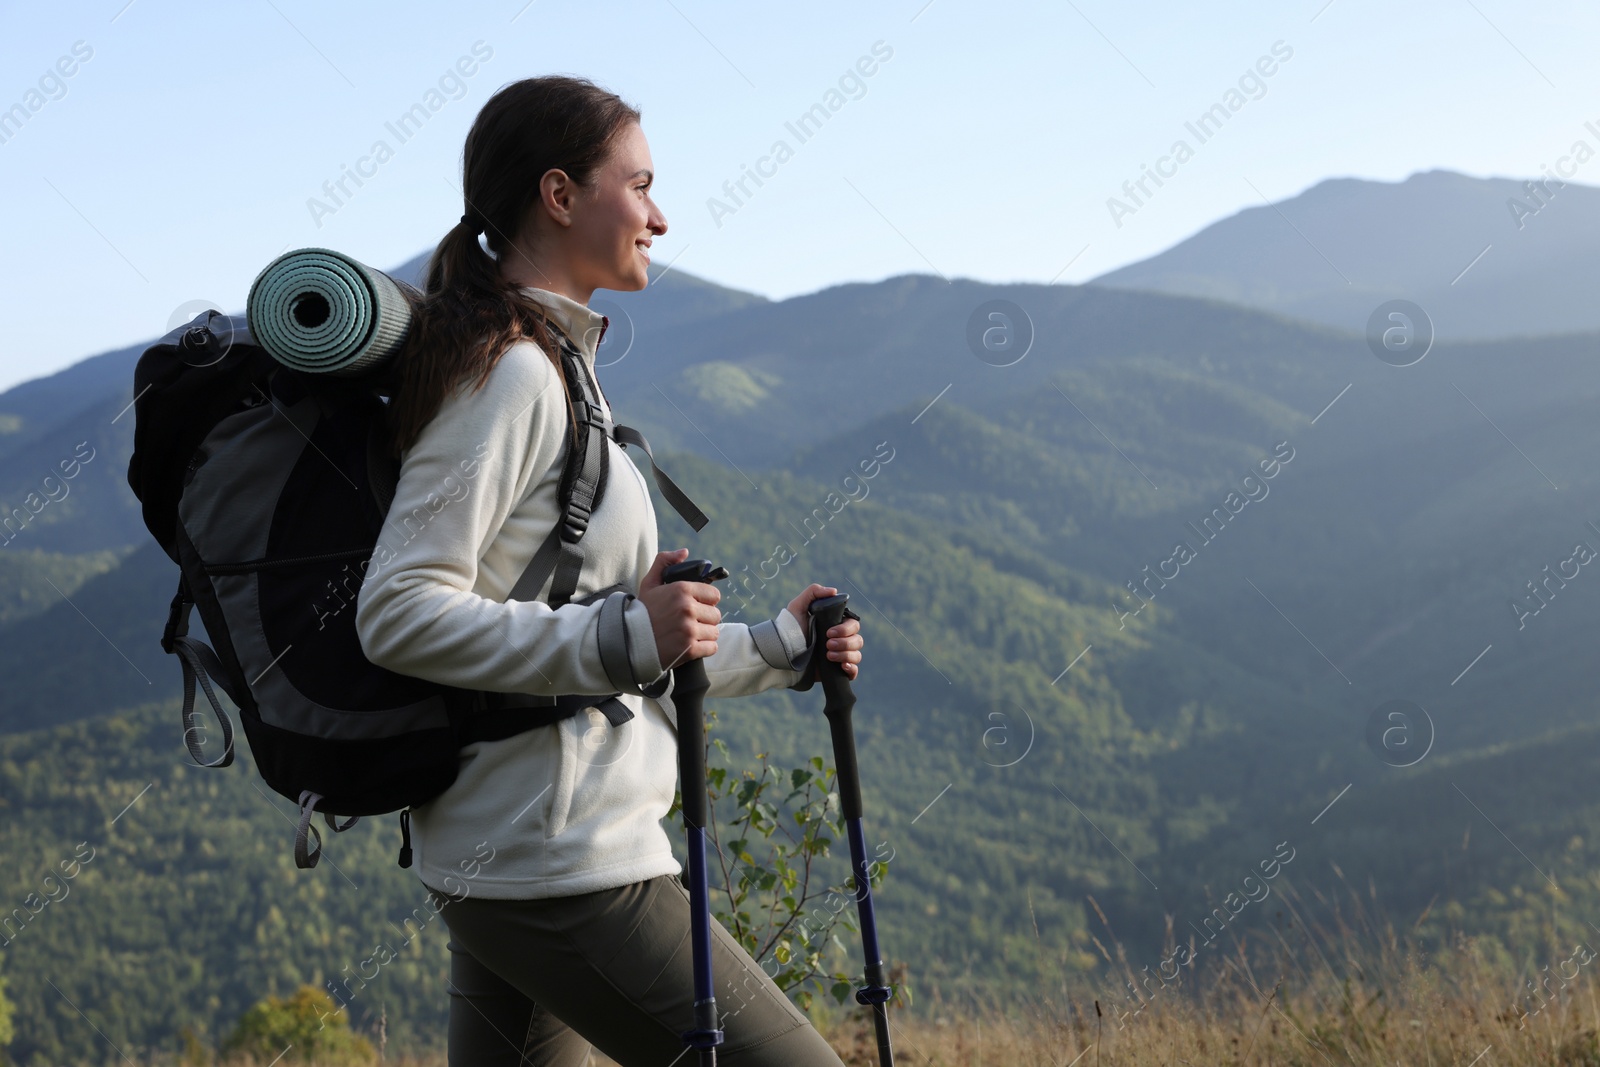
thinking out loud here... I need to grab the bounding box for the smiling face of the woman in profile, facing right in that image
[568,122,667,293]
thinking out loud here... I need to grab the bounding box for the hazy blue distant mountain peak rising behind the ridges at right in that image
[1091,168,1600,339]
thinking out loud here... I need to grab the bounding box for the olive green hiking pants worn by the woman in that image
[434,875,843,1067]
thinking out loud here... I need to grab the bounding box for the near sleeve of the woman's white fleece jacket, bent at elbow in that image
[355,341,662,694]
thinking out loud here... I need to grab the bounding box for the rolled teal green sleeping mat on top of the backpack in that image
[246,248,411,376]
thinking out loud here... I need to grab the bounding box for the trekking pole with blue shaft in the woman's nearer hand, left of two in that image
[661,560,728,1067]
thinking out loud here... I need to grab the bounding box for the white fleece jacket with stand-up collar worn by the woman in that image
[355,288,810,899]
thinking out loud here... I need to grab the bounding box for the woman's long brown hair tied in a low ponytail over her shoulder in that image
[387,75,638,459]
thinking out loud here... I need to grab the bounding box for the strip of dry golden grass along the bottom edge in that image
[203,966,1600,1067]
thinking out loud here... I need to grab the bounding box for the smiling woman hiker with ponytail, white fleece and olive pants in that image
[357,77,862,1067]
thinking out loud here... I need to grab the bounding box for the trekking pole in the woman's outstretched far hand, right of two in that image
[798,593,894,1067]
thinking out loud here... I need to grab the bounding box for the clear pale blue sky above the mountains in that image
[0,0,1600,389]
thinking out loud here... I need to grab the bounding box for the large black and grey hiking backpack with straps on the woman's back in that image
[128,310,707,867]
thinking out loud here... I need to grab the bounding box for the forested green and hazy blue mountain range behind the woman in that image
[0,171,1600,1062]
